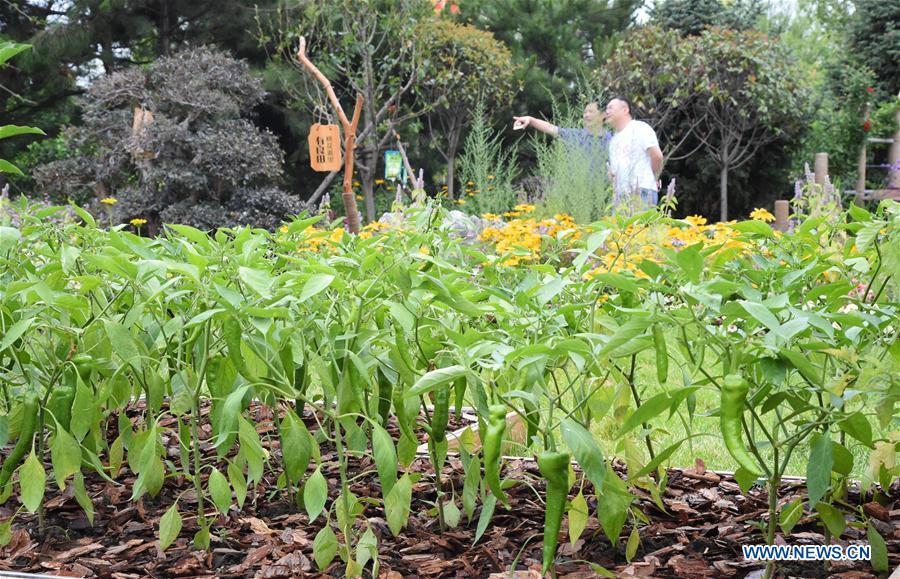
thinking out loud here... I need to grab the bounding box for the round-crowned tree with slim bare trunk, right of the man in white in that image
[693,29,805,221]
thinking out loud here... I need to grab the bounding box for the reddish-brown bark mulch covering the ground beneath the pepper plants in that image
[0,408,900,579]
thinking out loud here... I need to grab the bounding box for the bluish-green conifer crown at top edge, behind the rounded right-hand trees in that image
[650,0,765,36]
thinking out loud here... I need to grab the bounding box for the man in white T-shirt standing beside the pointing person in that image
[606,97,663,206]
